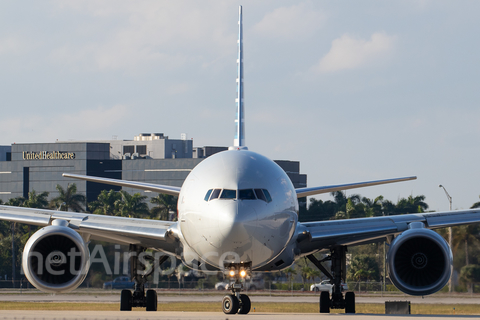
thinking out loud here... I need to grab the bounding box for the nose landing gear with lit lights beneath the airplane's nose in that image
[222,262,252,314]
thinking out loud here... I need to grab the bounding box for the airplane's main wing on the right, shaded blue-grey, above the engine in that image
[297,209,480,254]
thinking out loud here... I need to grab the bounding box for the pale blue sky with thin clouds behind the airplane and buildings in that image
[0,0,480,210]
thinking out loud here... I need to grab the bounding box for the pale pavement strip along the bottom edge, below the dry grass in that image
[0,310,479,320]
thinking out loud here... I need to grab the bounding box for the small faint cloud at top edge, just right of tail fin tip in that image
[253,3,326,40]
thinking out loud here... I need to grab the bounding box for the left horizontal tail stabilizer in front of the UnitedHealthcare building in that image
[62,173,181,196]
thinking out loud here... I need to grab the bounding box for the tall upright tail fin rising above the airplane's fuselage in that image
[233,6,245,147]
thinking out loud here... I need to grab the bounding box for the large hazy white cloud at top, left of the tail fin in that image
[47,1,235,72]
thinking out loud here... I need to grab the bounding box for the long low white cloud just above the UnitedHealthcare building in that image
[0,105,132,143]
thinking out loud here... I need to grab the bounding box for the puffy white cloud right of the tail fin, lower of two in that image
[315,32,396,73]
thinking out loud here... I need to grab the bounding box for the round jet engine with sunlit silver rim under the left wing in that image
[22,220,90,293]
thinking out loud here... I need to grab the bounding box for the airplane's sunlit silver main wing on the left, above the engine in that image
[0,206,177,253]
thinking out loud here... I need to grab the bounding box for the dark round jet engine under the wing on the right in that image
[387,222,453,296]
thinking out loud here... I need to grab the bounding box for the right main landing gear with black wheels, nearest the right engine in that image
[307,246,355,313]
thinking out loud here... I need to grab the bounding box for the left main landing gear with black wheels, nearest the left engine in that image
[120,245,168,311]
